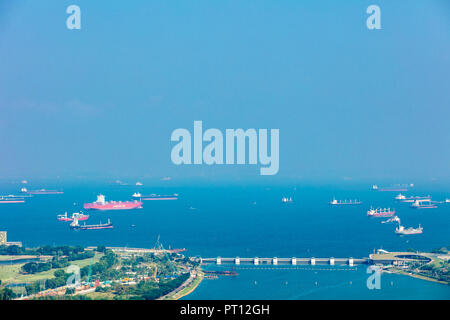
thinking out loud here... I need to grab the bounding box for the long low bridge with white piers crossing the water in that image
[199,257,370,266]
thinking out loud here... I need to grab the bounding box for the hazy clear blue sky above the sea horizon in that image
[0,0,450,181]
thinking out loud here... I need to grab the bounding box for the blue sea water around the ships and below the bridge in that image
[0,181,450,299]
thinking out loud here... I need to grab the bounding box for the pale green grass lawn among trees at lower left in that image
[0,253,103,284]
